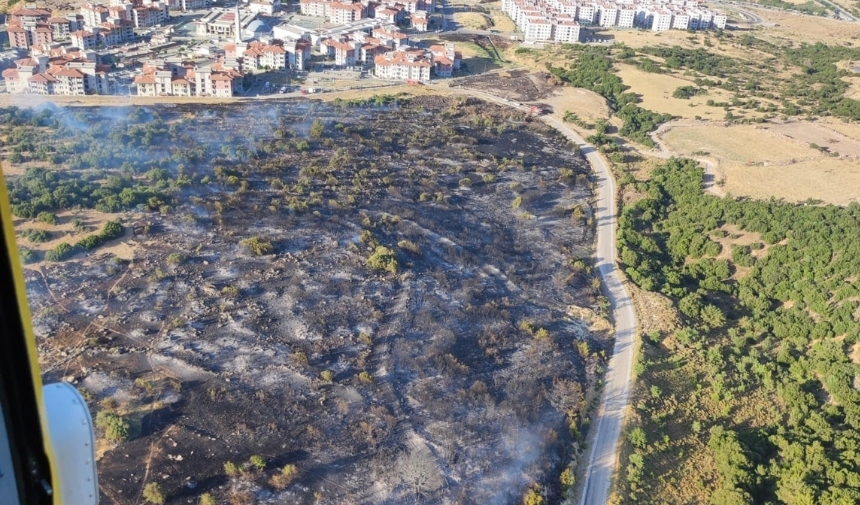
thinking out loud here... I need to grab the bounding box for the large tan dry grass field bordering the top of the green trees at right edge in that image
[662,125,860,205]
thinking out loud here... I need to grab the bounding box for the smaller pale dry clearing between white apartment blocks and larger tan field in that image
[616,64,736,120]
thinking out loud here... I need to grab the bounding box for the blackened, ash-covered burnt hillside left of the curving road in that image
[26,97,608,505]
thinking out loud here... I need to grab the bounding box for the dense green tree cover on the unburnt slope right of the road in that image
[619,159,860,504]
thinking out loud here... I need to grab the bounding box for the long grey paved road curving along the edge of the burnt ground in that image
[430,88,636,505]
